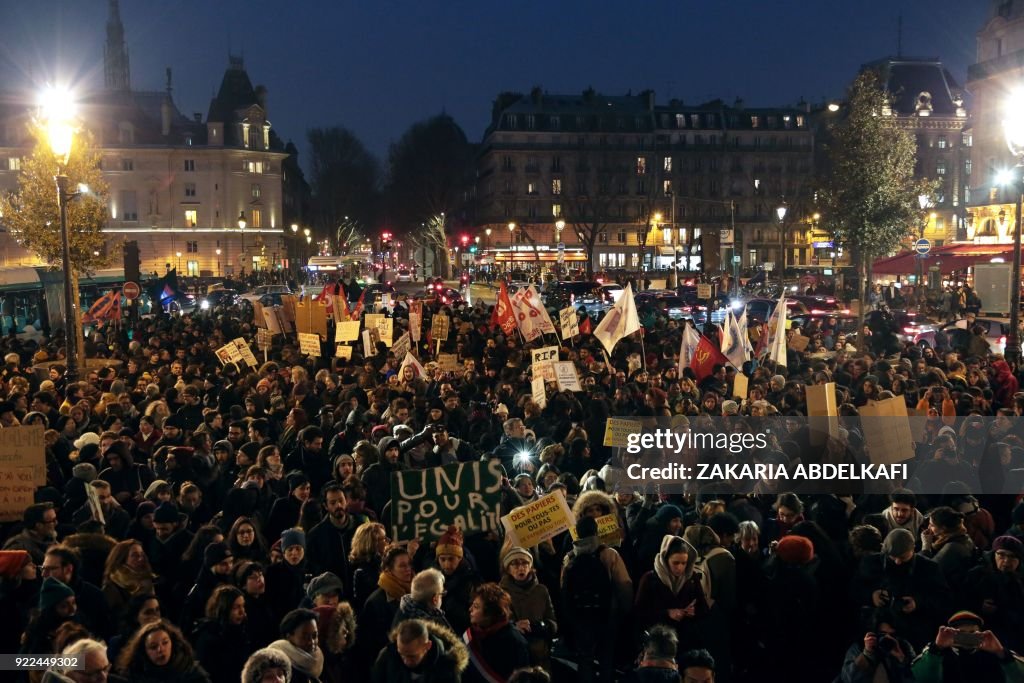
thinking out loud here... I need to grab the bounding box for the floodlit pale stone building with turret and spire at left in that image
[0,0,304,278]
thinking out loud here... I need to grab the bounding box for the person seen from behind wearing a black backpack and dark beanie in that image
[560,516,633,681]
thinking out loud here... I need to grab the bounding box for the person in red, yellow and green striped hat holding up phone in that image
[912,611,1024,683]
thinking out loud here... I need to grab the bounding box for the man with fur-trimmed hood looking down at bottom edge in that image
[372,620,469,683]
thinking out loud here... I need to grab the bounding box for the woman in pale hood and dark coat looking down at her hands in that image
[633,535,711,645]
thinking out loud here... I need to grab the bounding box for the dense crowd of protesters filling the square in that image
[0,284,1024,683]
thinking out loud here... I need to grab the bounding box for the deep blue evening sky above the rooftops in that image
[0,0,989,165]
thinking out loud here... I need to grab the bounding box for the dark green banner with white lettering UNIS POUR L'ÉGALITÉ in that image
[391,459,504,541]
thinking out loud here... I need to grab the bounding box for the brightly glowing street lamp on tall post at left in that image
[40,83,80,382]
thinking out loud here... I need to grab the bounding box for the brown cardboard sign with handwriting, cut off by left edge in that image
[0,425,46,521]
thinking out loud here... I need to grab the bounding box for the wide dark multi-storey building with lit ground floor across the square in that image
[476,89,819,272]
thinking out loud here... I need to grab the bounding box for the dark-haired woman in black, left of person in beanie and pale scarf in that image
[191,586,253,683]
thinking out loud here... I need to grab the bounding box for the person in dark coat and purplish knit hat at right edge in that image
[965,536,1024,652]
